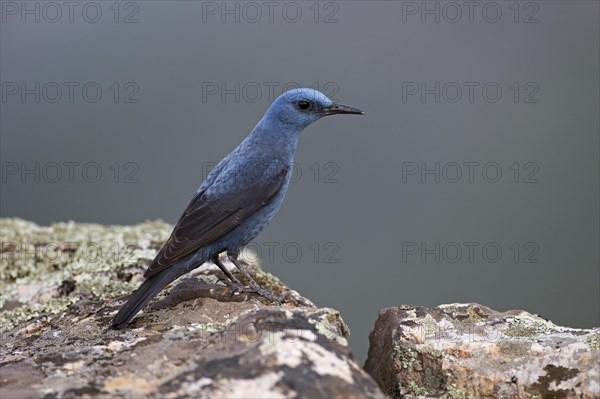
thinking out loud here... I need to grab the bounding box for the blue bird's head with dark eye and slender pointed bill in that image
[267,89,364,128]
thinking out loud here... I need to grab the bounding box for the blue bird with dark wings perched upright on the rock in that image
[112,88,364,329]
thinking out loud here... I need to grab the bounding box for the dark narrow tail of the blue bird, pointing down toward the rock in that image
[112,267,182,328]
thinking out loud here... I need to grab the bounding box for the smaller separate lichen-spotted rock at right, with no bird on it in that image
[365,304,600,398]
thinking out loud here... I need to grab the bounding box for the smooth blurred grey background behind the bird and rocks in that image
[0,1,600,360]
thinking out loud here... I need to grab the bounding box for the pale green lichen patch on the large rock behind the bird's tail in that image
[0,218,172,332]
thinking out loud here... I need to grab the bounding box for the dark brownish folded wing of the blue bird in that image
[144,166,289,278]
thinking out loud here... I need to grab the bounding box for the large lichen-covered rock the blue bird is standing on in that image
[0,219,383,399]
